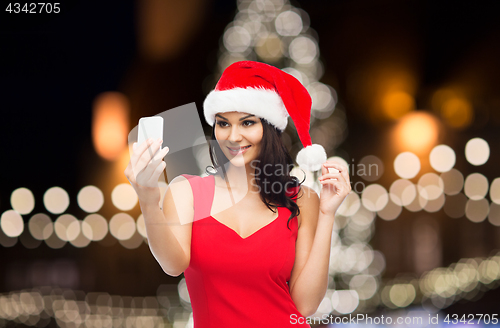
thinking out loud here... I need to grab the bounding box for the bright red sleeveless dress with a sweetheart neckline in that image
[183,174,311,328]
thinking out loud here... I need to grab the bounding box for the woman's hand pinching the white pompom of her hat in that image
[319,161,351,216]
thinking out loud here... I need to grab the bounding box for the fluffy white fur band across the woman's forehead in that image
[203,87,289,131]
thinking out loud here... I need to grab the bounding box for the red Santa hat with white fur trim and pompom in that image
[203,61,326,171]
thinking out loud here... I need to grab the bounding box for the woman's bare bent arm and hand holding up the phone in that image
[124,139,194,276]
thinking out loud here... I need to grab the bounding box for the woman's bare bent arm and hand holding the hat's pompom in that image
[289,162,351,317]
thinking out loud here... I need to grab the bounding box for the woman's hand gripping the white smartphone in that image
[125,139,169,205]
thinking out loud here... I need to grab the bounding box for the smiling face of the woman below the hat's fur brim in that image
[215,112,264,166]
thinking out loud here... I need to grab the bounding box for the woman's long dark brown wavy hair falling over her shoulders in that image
[206,118,305,229]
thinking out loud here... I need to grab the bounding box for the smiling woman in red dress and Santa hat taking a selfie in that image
[125,61,351,328]
